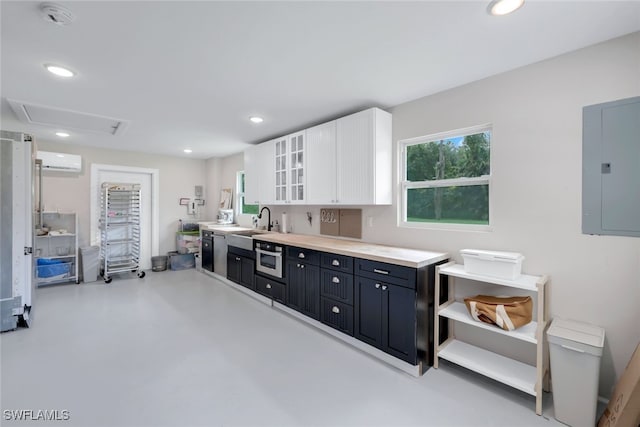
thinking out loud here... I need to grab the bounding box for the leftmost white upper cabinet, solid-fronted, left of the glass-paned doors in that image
[244,137,275,205]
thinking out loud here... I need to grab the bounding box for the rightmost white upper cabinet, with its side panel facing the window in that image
[336,108,392,205]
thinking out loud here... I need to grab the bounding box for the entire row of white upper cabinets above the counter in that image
[245,108,392,205]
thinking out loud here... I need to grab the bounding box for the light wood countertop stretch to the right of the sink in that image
[253,233,449,268]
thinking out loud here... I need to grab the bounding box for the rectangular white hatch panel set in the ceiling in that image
[7,99,130,135]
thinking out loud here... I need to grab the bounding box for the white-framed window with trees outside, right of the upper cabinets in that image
[399,125,492,230]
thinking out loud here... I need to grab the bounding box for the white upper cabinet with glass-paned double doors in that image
[274,131,306,204]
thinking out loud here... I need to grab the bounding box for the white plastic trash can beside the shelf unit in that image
[547,318,604,427]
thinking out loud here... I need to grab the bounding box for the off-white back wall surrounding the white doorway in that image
[37,140,209,255]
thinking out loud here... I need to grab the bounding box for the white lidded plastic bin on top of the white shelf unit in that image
[460,249,524,280]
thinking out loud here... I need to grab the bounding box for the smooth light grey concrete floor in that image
[0,270,560,426]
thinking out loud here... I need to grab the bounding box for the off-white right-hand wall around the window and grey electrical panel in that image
[224,33,640,396]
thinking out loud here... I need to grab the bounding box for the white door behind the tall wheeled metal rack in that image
[91,168,153,270]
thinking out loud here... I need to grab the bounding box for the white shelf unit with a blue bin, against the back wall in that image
[34,212,80,286]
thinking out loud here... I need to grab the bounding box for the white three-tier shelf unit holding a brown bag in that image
[433,262,549,415]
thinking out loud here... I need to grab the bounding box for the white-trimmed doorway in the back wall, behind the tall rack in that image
[91,164,160,270]
